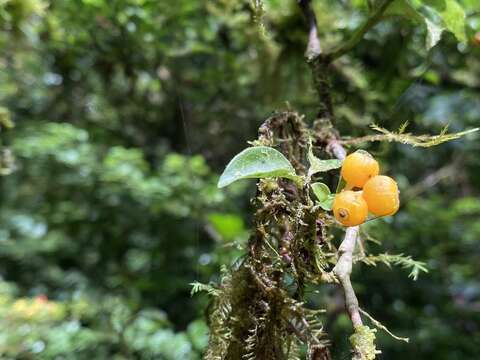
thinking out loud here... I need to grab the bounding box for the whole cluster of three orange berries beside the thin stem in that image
[333,150,400,226]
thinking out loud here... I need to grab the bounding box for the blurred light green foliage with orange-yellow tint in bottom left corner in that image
[0,282,207,360]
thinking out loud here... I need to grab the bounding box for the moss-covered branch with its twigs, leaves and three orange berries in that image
[194,0,478,360]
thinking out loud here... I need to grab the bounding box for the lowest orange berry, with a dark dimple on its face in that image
[333,190,368,226]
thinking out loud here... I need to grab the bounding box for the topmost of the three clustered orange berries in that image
[340,151,380,188]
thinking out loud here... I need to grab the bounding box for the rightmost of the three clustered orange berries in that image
[362,175,400,216]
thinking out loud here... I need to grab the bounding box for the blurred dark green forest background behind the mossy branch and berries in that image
[0,0,480,360]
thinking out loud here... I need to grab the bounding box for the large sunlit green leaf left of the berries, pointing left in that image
[217,146,302,188]
